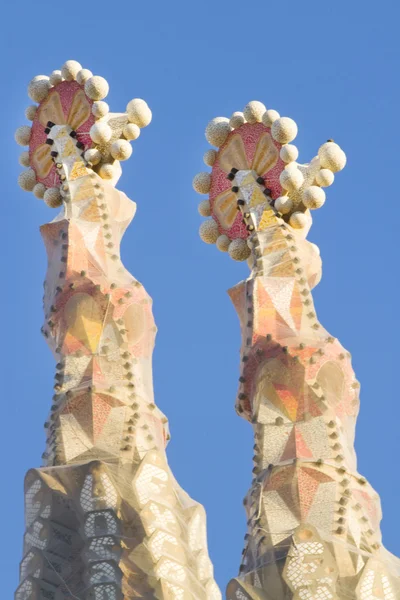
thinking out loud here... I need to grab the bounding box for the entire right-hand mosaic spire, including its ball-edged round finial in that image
[193,102,400,600]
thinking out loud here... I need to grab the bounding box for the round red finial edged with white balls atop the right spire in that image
[193,101,346,260]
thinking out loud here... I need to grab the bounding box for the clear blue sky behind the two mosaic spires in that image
[0,0,400,598]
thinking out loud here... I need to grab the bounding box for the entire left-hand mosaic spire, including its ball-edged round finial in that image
[15,61,221,600]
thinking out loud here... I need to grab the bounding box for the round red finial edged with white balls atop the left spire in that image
[15,60,152,207]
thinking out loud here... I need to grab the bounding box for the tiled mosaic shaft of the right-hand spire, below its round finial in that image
[223,126,400,600]
